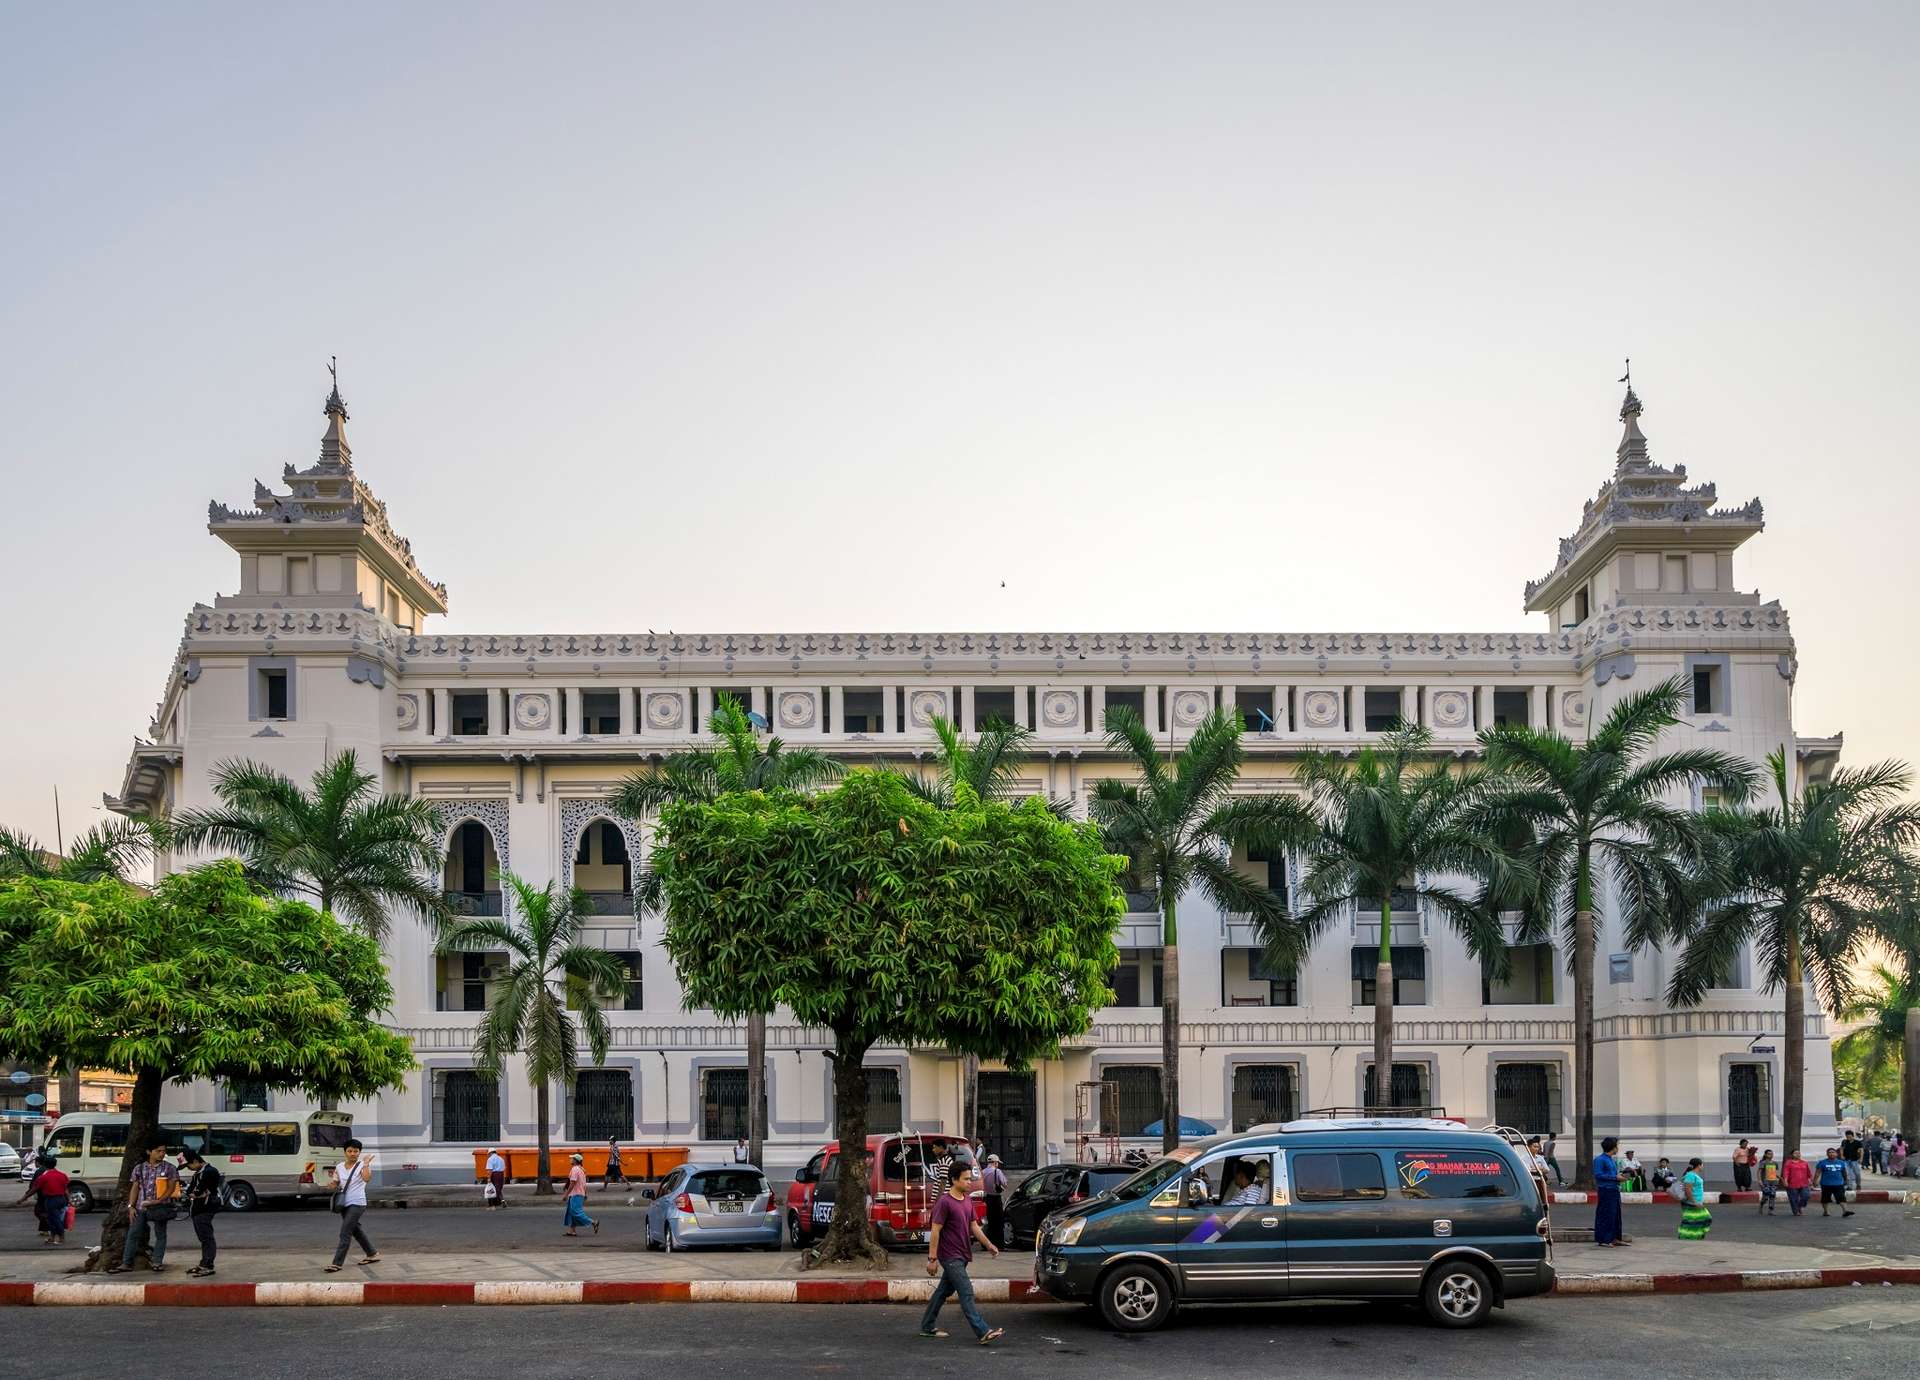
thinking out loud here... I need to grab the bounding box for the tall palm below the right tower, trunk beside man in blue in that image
[1480,679,1753,1188]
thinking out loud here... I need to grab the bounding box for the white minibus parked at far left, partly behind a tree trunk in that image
[46,1107,353,1213]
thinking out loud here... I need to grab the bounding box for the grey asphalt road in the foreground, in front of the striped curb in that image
[15,1288,1920,1380]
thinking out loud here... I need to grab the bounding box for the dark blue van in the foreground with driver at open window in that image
[1033,1117,1553,1332]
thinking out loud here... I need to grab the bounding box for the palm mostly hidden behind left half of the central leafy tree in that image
[609,695,843,1165]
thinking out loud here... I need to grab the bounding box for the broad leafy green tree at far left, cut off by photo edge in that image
[0,862,413,1267]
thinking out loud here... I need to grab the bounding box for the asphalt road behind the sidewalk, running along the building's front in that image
[0,1190,1920,1269]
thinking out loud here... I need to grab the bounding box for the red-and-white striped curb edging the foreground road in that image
[0,1265,1920,1307]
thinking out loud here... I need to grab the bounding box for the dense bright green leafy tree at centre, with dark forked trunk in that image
[655,772,1125,1259]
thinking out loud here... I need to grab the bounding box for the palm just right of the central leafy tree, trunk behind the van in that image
[1089,706,1311,1150]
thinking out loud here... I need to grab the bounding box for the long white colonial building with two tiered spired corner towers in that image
[111,390,1839,1178]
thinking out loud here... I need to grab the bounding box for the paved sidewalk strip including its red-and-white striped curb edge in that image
[0,1230,1920,1307]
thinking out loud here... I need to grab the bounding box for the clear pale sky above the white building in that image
[0,4,1920,843]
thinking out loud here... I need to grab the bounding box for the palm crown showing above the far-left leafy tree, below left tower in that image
[167,750,453,939]
